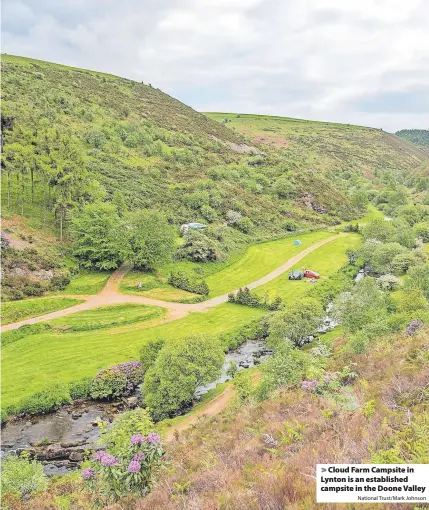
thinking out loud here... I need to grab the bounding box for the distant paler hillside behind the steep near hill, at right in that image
[206,113,429,184]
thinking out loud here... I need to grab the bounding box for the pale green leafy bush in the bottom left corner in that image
[1,455,48,498]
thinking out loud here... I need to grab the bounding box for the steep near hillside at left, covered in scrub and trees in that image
[2,55,355,243]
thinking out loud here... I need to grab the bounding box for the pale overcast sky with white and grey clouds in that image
[2,0,429,131]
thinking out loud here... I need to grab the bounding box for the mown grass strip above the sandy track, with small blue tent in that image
[120,231,334,301]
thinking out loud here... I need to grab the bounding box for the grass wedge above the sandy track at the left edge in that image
[1,297,82,325]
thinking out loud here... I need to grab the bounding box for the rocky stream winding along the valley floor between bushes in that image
[1,270,365,476]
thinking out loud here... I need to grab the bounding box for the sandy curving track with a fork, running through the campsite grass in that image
[1,233,347,333]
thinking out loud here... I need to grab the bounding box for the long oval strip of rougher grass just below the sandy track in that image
[49,304,166,332]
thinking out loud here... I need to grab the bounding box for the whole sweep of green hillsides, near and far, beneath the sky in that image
[2,55,425,247]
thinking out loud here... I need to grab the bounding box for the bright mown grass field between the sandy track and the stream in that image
[2,234,360,406]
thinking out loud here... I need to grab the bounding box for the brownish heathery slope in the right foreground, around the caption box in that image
[136,329,429,510]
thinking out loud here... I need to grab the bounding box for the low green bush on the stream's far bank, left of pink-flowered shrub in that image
[10,383,71,414]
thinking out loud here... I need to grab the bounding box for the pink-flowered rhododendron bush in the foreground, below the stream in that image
[81,432,166,503]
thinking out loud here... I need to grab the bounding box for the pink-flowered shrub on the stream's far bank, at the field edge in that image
[90,361,143,400]
